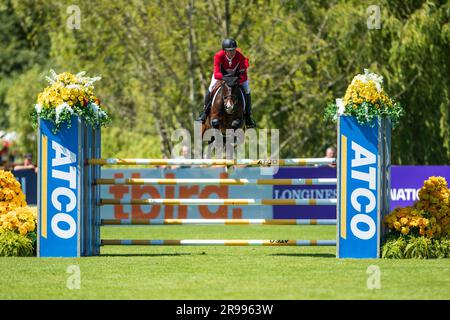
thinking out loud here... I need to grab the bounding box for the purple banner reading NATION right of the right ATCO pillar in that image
[391,166,450,211]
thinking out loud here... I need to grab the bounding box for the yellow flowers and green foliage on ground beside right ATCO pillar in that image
[383,176,450,258]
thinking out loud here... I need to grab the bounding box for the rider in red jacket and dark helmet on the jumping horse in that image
[197,38,256,128]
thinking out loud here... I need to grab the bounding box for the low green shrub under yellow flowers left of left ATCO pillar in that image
[0,230,34,257]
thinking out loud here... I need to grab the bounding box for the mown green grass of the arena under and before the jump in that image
[0,226,450,300]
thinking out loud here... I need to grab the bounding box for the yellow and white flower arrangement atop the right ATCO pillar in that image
[324,69,403,126]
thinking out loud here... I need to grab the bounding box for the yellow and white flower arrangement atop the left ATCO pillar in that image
[31,70,110,133]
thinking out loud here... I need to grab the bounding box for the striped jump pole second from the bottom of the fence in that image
[101,219,336,226]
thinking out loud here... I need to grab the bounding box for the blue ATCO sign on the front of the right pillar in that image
[337,116,383,258]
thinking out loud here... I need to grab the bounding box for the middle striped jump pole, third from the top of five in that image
[100,198,336,206]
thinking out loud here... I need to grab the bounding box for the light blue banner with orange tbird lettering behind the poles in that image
[100,167,272,219]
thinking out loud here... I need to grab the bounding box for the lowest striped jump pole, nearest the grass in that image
[101,239,336,246]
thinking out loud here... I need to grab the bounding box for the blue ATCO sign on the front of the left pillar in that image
[38,117,80,257]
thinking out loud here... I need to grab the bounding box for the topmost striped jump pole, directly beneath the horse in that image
[88,158,336,167]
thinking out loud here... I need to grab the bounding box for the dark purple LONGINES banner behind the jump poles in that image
[273,166,337,219]
